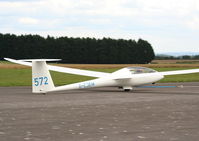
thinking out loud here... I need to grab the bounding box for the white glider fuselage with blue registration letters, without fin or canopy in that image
[51,68,164,91]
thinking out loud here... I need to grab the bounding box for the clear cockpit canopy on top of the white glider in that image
[127,67,157,74]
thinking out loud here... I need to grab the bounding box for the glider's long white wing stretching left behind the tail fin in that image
[4,58,110,77]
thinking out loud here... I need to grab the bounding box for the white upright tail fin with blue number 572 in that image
[31,60,55,93]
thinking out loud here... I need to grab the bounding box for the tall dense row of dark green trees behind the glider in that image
[0,34,155,64]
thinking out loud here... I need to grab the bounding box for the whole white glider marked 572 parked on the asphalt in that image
[4,58,199,94]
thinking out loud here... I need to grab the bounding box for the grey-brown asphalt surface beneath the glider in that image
[0,83,199,141]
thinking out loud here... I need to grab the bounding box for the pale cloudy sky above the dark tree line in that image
[0,0,199,53]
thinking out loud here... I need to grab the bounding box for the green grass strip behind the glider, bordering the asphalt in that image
[0,68,199,86]
